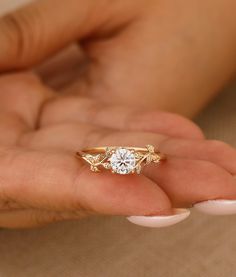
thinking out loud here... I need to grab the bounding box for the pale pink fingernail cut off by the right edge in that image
[194,200,236,215]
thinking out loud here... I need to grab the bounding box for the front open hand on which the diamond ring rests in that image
[0,71,236,228]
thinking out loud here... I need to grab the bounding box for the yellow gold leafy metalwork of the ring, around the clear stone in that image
[76,145,166,174]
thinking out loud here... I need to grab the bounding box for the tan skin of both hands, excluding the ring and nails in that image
[0,0,236,228]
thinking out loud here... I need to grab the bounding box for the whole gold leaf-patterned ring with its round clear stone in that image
[76,145,166,174]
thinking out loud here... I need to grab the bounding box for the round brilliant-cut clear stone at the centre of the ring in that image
[110,148,135,174]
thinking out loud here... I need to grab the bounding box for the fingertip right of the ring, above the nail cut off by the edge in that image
[144,158,236,207]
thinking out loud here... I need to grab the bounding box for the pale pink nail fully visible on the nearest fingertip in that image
[127,209,190,228]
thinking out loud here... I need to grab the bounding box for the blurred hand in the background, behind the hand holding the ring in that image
[0,0,236,116]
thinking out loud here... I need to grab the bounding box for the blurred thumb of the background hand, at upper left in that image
[0,0,103,70]
